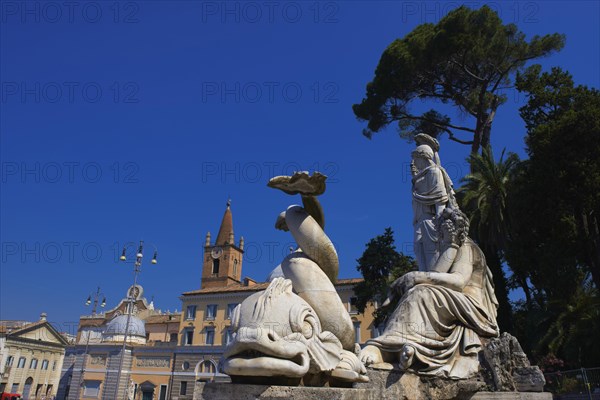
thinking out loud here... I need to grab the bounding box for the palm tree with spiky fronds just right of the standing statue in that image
[458,145,519,331]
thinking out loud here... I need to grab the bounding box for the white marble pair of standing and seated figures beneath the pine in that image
[360,134,499,379]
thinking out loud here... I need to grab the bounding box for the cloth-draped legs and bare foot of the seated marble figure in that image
[361,284,495,378]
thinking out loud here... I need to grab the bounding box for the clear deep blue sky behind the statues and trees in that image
[0,0,600,330]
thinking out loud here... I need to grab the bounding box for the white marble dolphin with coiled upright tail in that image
[221,172,368,386]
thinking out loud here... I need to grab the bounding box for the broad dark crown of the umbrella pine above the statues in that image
[353,6,565,153]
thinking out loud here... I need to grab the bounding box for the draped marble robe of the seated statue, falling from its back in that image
[366,239,499,379]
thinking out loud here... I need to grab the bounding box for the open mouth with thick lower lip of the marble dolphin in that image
[222,349,310,378]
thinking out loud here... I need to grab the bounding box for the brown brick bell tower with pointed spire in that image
[200,199,244,289]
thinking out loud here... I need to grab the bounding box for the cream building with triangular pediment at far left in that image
[0,314,68,399]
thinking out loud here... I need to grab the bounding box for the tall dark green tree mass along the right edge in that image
[505,65,600,368]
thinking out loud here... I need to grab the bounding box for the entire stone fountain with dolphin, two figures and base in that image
[194,134,552,400]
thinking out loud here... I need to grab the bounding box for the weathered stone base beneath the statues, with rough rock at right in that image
[194,333,552,400]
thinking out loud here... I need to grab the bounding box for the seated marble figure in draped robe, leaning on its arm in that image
[360,208,499,379]
